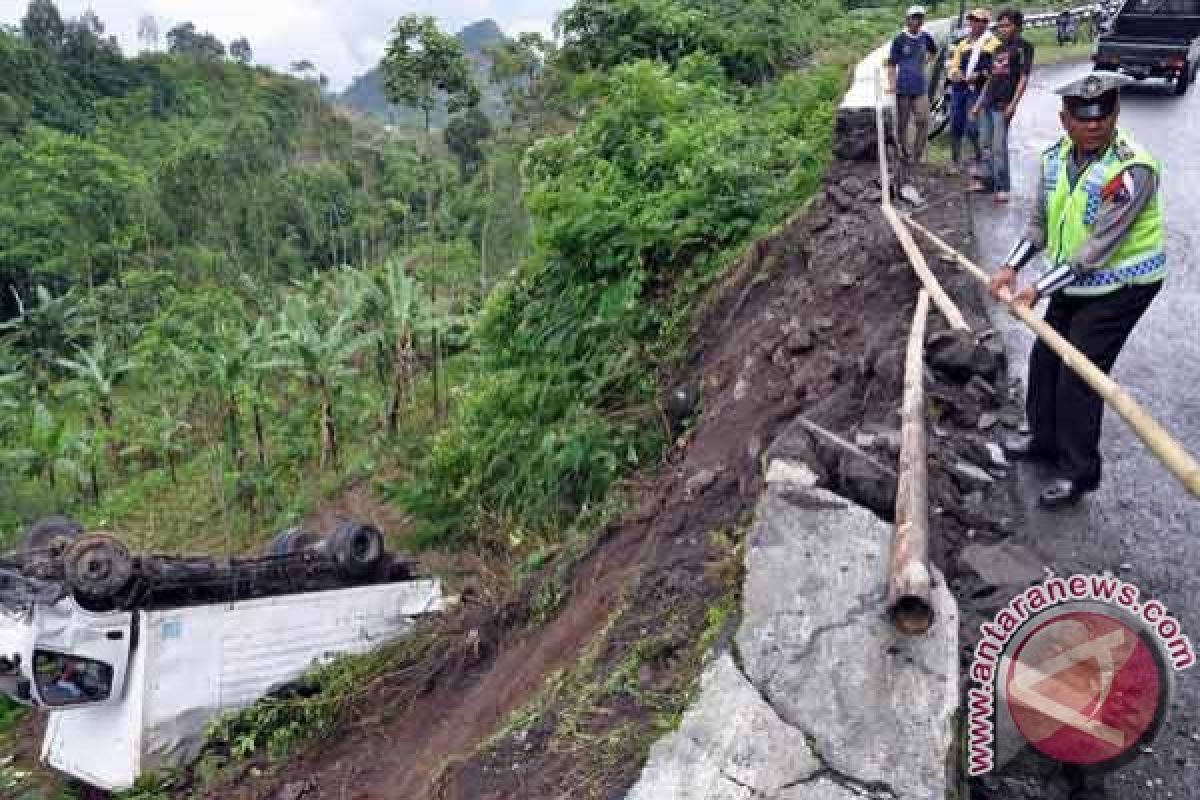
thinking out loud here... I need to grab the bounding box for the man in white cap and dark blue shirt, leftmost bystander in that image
[884,6,937,162]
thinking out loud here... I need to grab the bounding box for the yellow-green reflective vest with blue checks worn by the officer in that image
[1042,131,1166,295]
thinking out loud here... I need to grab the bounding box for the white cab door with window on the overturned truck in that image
[29,601,136,710]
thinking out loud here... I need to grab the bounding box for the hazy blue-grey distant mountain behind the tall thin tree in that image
[336,19,508,127]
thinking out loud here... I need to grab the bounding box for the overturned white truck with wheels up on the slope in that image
[0,517,443,790]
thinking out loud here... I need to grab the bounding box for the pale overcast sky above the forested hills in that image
[0,0,569,90]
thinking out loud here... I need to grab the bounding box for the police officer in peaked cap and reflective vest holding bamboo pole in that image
[991,72,1166,509]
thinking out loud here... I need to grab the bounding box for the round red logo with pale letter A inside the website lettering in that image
[1001,603,1171,770]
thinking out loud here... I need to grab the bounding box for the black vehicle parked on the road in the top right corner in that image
[1092,0,1200,95]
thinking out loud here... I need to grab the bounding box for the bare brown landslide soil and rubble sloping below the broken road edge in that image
[145,163,1019,800]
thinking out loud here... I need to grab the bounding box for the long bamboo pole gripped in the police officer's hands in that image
[905,217,1200,498]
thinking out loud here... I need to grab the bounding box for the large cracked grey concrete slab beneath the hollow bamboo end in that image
[628,463,959,800]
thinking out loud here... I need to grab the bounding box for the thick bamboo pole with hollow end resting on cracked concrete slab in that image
[887,289,934,634]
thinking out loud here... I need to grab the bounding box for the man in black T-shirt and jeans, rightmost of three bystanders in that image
[970,8,1033,203]
